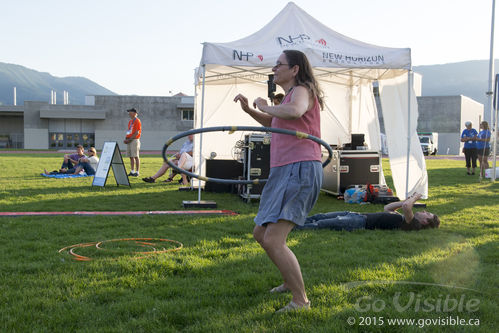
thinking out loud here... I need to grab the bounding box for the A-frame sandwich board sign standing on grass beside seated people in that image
[92,141,131,187]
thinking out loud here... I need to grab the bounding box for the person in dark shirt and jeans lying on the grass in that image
[295,193,440,231]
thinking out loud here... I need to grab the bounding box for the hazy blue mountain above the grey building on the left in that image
[0,62,116,105]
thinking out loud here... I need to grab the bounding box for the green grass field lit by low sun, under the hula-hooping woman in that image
[0,151,499,332]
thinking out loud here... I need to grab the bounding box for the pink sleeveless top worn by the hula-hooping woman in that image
[270,88,321,168]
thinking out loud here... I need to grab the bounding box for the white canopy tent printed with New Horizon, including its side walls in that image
[194,2,428,199]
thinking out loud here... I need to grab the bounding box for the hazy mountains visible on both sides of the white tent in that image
[0,60,499,105]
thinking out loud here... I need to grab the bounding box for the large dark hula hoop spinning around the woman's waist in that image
[162,126,333,185]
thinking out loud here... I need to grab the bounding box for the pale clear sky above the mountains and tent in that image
[0,0,497,96]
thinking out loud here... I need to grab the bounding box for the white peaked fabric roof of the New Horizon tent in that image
[201,2,411,83]
